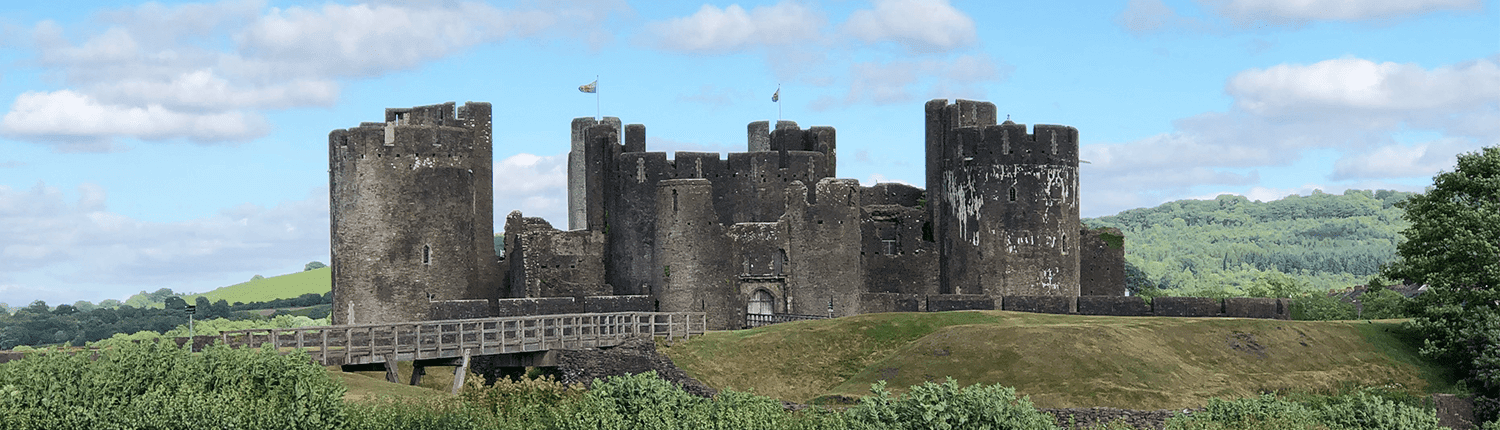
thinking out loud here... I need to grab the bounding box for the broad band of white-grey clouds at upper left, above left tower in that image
[0,0,612,151]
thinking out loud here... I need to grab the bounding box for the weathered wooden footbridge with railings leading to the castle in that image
[221,312,708,393]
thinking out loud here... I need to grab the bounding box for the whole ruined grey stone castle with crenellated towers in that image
[329,100,1125,330]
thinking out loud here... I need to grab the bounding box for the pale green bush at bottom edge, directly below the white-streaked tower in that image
[848,378,1056,430]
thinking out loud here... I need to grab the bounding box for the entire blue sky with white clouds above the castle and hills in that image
[0,0,1500,306]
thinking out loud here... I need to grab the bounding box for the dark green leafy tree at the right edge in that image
[1383,147,1500,421]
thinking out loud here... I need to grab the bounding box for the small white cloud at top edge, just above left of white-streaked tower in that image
[843,0,978,52]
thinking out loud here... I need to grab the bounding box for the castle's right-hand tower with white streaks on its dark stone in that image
[927,100,1079,297]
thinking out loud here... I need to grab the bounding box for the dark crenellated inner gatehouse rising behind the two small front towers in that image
[594,118,834,302]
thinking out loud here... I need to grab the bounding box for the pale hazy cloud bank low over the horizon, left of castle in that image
[0,184,329,304]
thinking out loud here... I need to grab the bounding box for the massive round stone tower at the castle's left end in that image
[329,103,495,324]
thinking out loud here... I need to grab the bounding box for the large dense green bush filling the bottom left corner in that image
[0,342,347,429]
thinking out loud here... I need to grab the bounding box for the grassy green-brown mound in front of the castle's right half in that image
[662,312,1452,409]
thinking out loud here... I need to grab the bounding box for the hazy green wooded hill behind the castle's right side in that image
[1083,190,1413,297]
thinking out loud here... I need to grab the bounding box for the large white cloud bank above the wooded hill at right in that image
[1080,58,1500,214]
